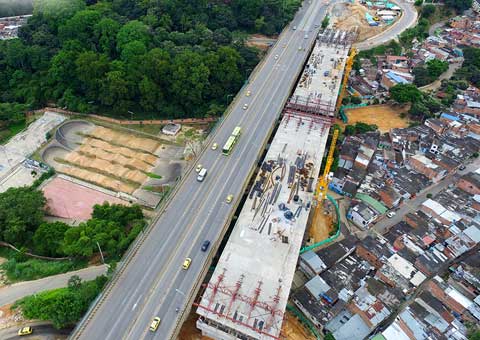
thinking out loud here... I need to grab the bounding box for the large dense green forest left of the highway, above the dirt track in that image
[0,0,299,118]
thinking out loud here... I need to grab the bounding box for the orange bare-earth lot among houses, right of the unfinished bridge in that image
[345,105,409,132]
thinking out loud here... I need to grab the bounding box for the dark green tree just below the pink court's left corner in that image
[33,222,70,257]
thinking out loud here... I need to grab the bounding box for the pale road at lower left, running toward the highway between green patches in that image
[0,265,107,306]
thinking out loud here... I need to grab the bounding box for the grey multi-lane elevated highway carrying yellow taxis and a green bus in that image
[71,1,329,340]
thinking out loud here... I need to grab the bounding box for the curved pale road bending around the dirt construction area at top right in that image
[354,0,418,50]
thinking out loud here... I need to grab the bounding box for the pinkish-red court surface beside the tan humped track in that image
[43,177,128,221]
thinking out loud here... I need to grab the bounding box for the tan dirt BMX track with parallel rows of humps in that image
[43,121,164,194]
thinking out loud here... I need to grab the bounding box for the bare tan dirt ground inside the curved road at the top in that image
[330,2,389,41]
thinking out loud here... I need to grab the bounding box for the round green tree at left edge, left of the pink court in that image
[0,187,46,247]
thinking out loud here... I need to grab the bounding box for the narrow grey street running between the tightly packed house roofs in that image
[373,158,480,234]
